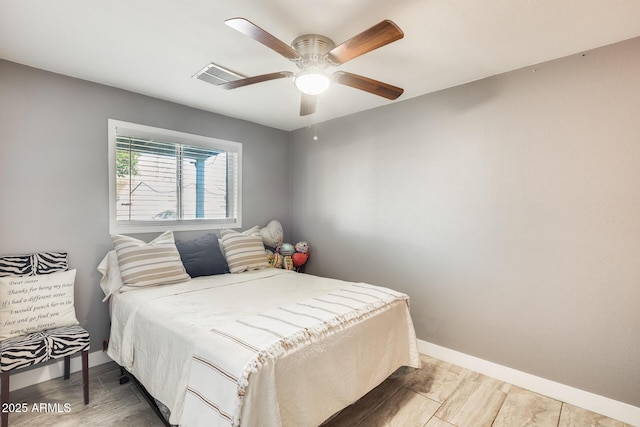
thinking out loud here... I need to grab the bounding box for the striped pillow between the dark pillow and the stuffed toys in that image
[220,226,269,273]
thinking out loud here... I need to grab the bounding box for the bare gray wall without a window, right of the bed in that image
[290,39,640,406]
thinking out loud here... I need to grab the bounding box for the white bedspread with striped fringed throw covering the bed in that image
[108,269,420,426]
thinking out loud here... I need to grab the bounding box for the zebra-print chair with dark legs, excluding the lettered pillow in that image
[0,252,90,427]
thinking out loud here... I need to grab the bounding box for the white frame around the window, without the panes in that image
[108,119,242,234]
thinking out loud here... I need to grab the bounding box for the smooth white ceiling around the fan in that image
[0,0,640,130]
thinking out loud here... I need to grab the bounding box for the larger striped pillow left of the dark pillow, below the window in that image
[111,230,190,291]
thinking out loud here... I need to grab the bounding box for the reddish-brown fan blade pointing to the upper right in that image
[327,19,404,65]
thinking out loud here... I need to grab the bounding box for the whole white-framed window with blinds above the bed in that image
[109,119,242,234]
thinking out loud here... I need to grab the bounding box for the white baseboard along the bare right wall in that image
[418,340,640,426]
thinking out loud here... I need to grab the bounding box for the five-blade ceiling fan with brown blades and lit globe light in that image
[218,18,404,116]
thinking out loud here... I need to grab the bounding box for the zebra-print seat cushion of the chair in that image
[0,325,89,372]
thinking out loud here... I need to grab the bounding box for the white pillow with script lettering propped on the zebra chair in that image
[0,270,78,340]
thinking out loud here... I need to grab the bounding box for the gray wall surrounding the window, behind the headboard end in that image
[0,60,289,351]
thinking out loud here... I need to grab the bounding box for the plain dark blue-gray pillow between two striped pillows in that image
[176,233,229,277]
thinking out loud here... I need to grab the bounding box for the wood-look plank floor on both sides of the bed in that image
[3,355,630,427]
